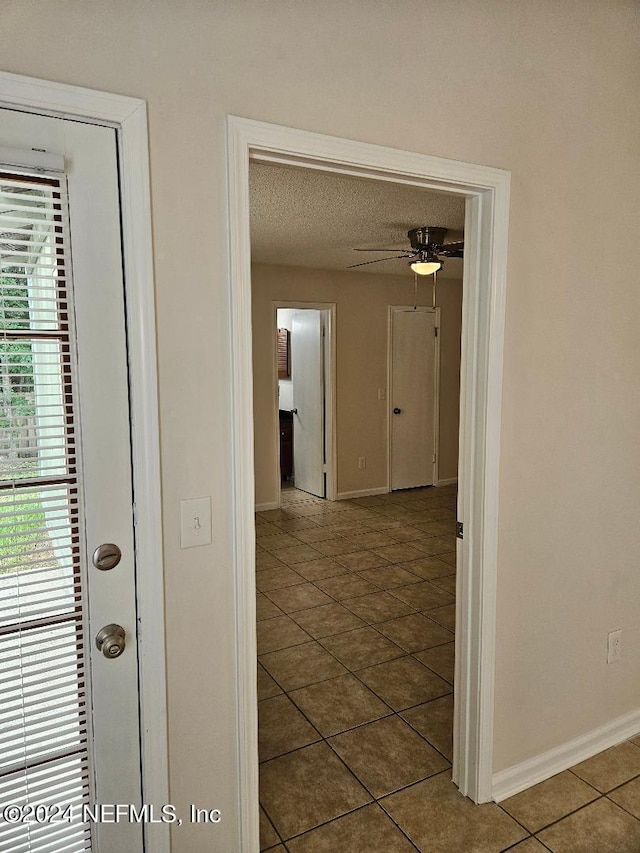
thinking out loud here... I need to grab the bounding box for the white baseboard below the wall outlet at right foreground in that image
[492,710,640,803]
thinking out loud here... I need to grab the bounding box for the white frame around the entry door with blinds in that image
[0,72,169,853]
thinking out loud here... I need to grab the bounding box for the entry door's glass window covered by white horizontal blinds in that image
[0,172,91,853]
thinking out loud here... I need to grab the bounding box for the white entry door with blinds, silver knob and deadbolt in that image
[0,109,143,853]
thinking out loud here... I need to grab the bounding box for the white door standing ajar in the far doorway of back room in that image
[291,308,325,498]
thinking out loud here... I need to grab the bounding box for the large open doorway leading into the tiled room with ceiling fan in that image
[250,155,464,844]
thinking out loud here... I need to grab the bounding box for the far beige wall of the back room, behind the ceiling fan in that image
[252,264,462,504]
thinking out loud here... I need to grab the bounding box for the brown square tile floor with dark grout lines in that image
[256,487,640,853]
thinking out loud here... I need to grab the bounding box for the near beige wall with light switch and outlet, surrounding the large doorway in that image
[0,0,640,853]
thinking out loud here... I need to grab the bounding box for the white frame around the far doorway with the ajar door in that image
[271,300,338,508]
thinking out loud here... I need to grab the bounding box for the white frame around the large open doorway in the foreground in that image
[227,116,510,853]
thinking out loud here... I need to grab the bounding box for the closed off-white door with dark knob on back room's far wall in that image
[390,308,436,489]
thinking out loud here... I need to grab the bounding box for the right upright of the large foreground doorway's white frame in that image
[453,176,510,803]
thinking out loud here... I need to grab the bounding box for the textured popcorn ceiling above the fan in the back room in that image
[249,162,464,277]
